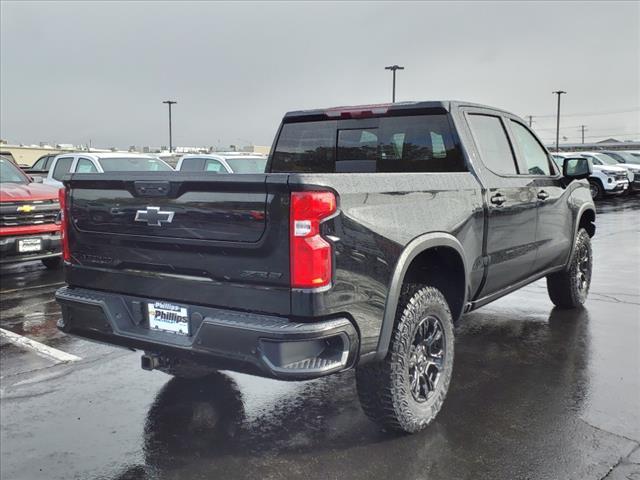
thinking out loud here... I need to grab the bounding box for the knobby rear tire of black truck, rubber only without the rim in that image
[356,285,454,433]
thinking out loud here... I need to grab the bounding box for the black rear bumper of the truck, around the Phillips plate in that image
[56,287,359,380]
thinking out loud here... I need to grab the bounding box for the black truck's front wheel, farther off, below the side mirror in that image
[547,228,593,308]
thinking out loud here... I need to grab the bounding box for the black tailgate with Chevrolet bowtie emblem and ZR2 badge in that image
[65,172,290,314]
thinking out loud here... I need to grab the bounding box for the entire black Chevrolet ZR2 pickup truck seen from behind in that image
[56,101,595,432]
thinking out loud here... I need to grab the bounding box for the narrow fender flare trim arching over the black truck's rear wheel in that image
[375,232,469,360]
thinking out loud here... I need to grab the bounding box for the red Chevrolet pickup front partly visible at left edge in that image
[0,157,61,268]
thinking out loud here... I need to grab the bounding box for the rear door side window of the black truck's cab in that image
[469,114,518,175]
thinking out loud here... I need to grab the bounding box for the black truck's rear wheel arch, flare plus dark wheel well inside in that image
[375,232,468,360]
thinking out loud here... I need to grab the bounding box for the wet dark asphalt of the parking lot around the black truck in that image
[0,196,640,480]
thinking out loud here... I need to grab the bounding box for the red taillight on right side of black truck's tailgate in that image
[289,192,336,288]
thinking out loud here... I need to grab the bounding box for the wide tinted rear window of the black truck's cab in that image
[271,114,467,173]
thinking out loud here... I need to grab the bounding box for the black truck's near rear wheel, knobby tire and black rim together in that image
[356,285,453,433]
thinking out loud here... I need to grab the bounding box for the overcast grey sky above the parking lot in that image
[0,1,640,147]
